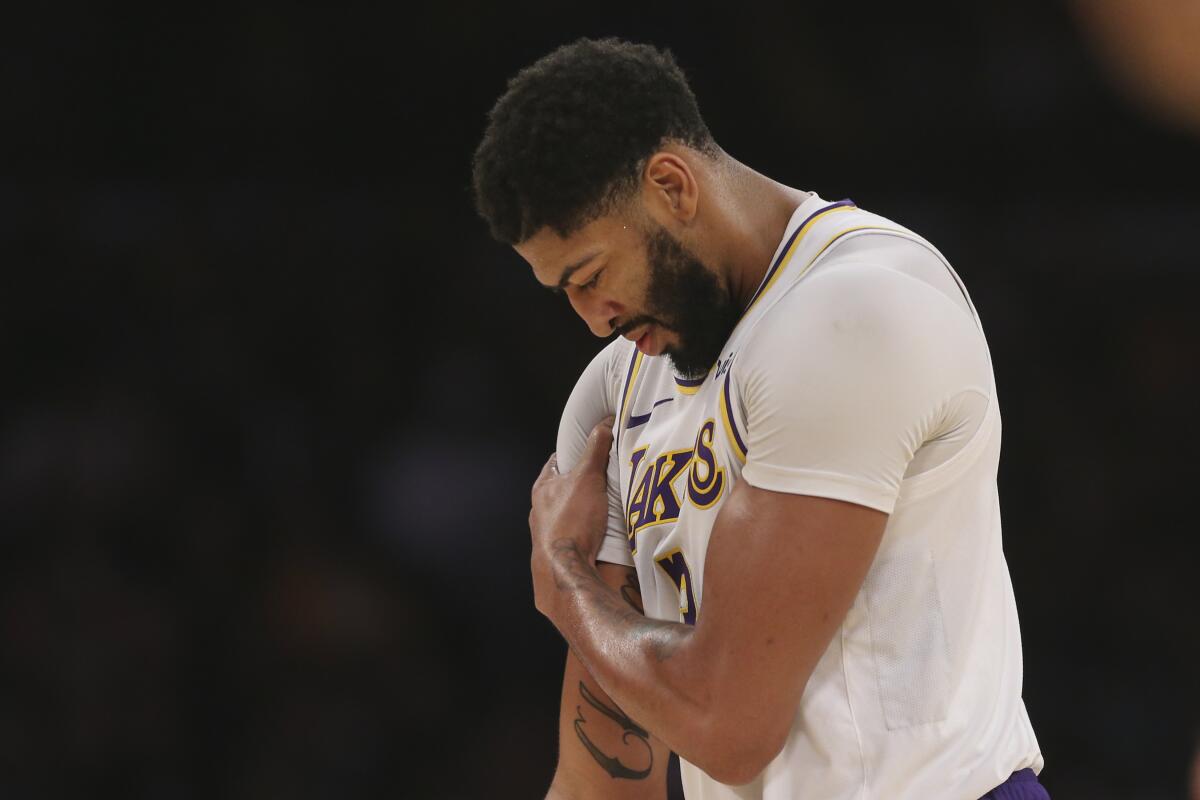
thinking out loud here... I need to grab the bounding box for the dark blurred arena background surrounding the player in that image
[0,0,1200,800]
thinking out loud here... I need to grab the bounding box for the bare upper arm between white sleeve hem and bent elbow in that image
[696,481,888,745]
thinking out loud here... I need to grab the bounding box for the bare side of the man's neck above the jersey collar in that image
[720,158,811,308]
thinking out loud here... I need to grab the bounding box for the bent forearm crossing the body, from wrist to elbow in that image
[546,540,712,760]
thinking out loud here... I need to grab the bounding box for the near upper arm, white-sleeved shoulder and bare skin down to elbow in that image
[696,265,991,777]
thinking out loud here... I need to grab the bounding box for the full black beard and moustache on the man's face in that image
[622,227,743,380]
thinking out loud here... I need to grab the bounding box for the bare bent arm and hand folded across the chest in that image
[529,421,887,784]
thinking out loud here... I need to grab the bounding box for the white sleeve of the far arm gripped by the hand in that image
[554,339,634,566]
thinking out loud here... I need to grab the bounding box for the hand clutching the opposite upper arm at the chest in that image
[529,416,613,616]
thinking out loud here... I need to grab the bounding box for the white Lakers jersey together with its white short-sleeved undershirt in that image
[558,196,1043,800]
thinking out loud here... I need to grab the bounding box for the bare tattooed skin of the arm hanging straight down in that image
[548,564,671,800]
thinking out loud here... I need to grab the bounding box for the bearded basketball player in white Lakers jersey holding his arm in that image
[474,40,1048,800]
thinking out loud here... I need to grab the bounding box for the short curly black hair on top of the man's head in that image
[474,38,718,245]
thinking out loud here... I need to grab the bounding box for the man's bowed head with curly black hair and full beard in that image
[474,40,740,377]
